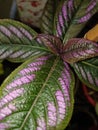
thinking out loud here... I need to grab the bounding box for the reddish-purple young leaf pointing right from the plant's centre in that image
[62,38,98,64]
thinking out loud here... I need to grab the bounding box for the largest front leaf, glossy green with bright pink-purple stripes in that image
[0,56,74,130]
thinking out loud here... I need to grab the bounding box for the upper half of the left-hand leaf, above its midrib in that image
[0,19,37,45]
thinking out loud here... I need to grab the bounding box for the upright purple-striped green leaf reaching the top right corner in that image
[56,0,98,43]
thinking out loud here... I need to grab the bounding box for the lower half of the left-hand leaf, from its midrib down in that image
[0,44,49,62]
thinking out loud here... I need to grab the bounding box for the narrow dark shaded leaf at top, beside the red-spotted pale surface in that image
[41,0,59,34]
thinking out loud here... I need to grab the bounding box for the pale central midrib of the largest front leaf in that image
[19,57,59,130]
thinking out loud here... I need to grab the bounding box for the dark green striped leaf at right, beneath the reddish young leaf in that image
[72,57,98,91]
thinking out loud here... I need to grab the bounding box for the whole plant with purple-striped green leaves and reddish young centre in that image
[0,0,98,130]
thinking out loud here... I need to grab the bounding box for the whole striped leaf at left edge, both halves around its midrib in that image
[0,19,47,62]
